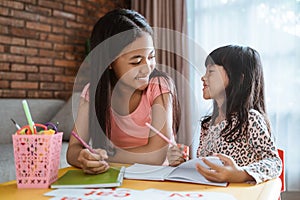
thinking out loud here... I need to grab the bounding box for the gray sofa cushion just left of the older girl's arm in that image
[51,93,80,141]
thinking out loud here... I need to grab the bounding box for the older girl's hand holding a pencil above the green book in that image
[78,149,109,174]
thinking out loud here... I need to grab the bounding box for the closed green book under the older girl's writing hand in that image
[51,167,125,188]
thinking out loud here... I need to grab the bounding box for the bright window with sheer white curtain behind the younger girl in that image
[187,0,300,191]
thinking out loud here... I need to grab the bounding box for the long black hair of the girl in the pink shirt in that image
[90,9,180,149]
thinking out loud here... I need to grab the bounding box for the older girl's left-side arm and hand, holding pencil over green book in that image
[67,97,108,174]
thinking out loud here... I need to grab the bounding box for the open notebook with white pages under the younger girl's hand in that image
[124,157,227,186]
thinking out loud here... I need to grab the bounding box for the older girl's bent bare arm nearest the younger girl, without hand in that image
[109,93,173,165]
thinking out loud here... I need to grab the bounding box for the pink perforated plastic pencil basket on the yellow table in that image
[12,132,63,188]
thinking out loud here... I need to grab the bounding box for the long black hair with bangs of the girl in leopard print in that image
[201,45,270,142]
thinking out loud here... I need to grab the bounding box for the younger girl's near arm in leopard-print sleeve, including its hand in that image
[197,111,282,184]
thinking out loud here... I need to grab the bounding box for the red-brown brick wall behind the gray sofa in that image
[0,0,130,99]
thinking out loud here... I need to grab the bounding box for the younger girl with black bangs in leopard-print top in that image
[168,46,282,183]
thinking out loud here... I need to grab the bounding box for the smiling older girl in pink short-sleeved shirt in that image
[67,9,178,174]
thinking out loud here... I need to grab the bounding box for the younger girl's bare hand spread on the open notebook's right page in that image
[196,154,254,183]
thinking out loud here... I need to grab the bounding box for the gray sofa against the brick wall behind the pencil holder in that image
[0,94,79,183]
